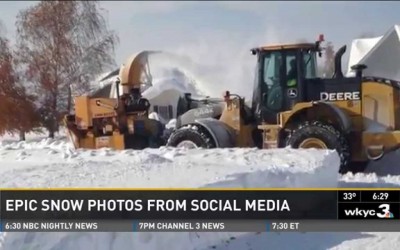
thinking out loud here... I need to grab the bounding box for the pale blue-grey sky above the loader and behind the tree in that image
[0,1,400,62]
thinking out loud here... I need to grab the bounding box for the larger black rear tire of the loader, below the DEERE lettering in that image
[286,121,351,173]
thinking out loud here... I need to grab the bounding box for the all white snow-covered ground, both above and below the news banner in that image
[0,132,400,250]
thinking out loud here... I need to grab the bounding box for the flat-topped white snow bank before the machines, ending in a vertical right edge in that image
[0,140,338,187]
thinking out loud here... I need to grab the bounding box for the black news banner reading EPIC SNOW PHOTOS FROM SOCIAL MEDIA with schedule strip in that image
[0,189,400,232]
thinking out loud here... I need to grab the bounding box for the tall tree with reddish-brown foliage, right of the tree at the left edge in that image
[17,1,118,138]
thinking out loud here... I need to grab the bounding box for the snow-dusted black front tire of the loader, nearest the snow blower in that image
[167,125,216,148]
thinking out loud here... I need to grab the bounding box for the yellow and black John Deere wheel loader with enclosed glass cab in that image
[167,35,400,172]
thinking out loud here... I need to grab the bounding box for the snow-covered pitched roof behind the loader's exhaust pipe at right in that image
[347,25,400,81]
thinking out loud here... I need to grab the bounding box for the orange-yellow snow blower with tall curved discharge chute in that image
[64,51,165,149]
